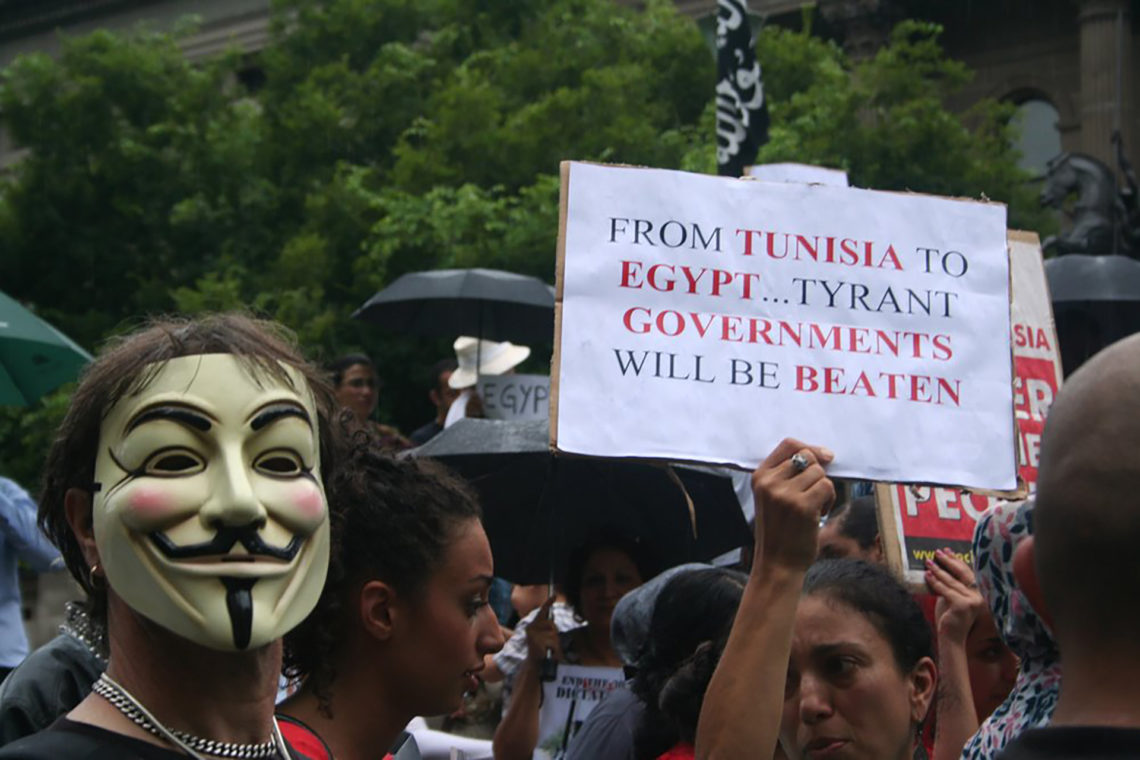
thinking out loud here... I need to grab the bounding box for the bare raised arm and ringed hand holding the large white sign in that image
[697,439,836,760]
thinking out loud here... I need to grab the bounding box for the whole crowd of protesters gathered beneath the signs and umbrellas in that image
[0,313,1140,760]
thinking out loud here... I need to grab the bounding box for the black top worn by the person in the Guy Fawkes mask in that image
[0,718,304,760]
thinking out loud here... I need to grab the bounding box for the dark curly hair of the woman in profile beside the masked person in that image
[285,437,481,717]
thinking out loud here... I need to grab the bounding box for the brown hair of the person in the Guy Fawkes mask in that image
[39,312,336,621]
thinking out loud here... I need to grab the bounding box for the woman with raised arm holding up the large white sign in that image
[694,439,937,760]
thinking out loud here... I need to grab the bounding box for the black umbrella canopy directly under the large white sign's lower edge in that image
[410,419,751,583]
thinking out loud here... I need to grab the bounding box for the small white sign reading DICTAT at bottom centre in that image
[534,664,625,760]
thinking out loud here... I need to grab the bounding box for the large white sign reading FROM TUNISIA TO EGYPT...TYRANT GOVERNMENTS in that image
[551,163,1016,489]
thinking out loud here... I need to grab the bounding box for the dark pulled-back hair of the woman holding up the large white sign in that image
[804,559,934,673]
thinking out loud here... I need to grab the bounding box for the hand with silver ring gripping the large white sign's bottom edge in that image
[752,438,836,570]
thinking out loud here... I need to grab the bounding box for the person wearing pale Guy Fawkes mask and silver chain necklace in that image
[0,314,336,760]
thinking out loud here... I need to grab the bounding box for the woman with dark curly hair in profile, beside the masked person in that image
[279,433,503,760]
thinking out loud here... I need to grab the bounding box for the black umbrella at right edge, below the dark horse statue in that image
[1045,253,1140,375]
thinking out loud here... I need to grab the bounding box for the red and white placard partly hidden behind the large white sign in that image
[876,231,1061,585]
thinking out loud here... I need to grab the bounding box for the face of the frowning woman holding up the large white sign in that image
[780,595,936,760]
